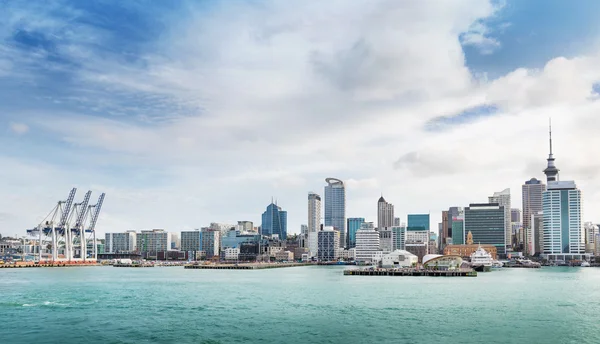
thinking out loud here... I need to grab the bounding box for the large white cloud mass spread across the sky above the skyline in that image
[0,1,600,239]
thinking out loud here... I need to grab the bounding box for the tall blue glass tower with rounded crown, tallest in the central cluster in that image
[324,178,346,247]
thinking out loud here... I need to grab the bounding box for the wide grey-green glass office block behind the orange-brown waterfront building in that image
[464,203,510,256]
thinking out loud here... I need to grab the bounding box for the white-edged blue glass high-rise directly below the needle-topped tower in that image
[542,181,585,261]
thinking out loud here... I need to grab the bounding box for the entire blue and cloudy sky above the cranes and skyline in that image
[0,0,600,236]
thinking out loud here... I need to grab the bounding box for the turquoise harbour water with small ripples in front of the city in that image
[0,267,600,344]
